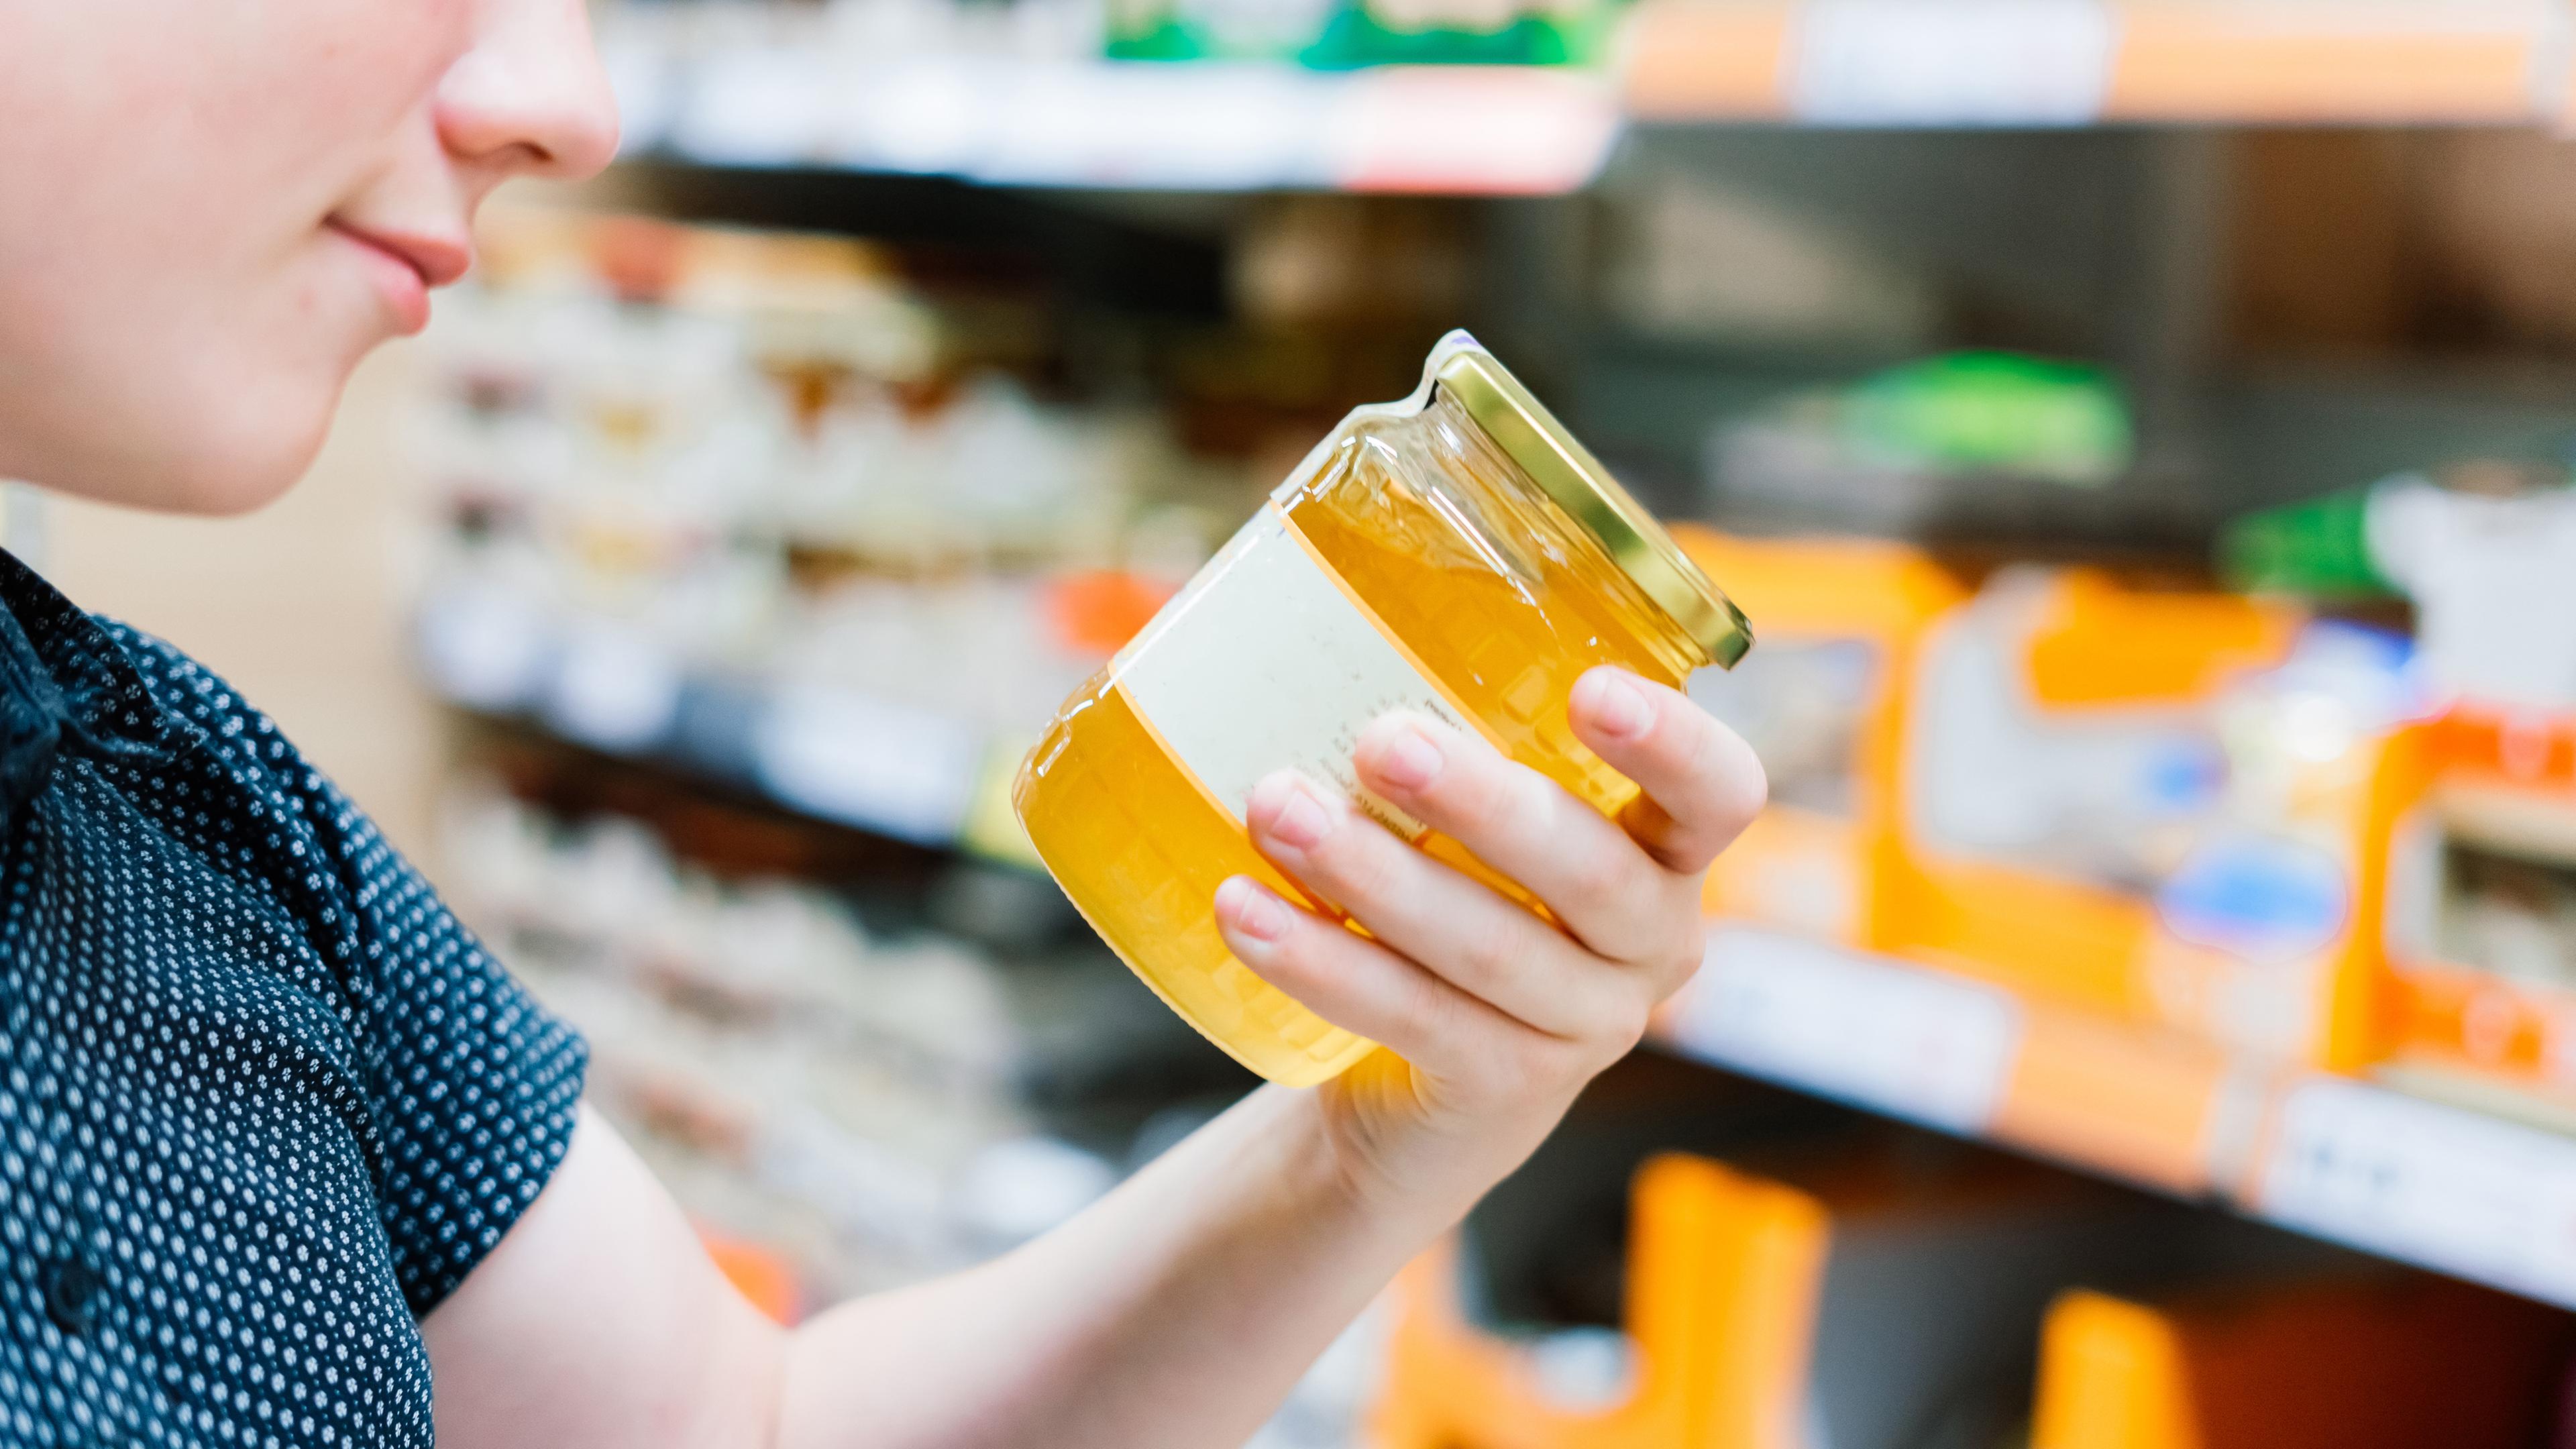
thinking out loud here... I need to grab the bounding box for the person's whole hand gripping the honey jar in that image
[1216,667,1764,1227]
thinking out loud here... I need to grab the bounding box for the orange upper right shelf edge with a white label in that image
[1623,0,2571,126]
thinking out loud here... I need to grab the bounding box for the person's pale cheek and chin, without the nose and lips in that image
[0,0,474,508]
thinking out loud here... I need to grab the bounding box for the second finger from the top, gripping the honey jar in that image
[1355,714,1698,962]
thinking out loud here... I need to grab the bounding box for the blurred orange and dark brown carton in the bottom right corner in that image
[2030,1274,2571,1449]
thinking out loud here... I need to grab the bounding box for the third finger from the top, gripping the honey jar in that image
[1244,771,1620,1036]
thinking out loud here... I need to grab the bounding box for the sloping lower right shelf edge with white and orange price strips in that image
[1659,926,2576,1307]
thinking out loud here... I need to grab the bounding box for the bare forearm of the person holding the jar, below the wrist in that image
[781,1088,1453,1449]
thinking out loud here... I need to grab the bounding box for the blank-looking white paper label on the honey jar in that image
[1118,508,1471,835]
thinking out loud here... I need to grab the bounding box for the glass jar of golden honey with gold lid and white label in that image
[1012,333,1752,1085]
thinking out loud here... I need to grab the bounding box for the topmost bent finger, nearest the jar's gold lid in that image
[1569,665,1770,874]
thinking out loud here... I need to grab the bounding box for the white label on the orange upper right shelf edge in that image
[1790,0,2117,126]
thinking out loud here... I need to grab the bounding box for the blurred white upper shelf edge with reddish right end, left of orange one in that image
[610,46,1620,196]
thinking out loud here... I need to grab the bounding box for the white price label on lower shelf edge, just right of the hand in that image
[1672,926,2022,1132]
